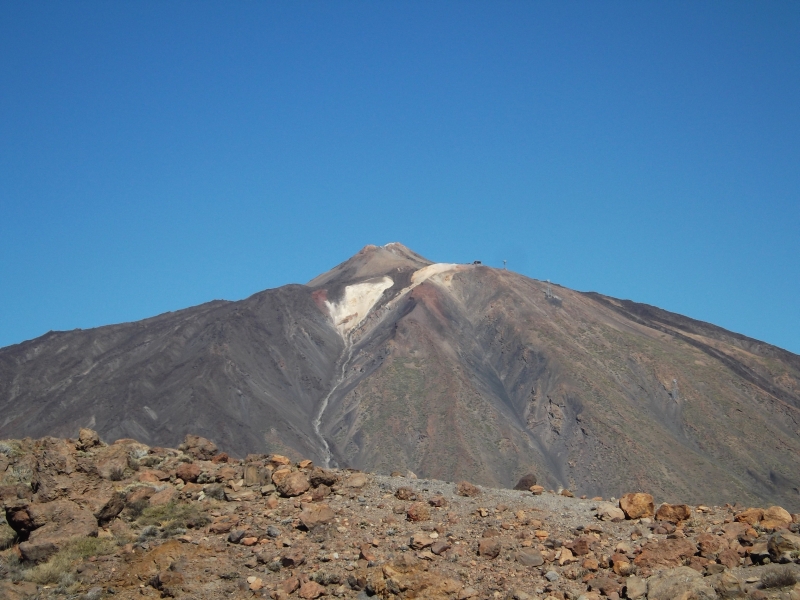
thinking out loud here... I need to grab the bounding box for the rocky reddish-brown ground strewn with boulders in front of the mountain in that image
[0,429,800,600]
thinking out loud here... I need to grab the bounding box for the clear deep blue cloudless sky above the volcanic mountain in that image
[0,0,800,353]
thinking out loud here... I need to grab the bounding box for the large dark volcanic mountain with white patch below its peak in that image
[0,243,800,511]
